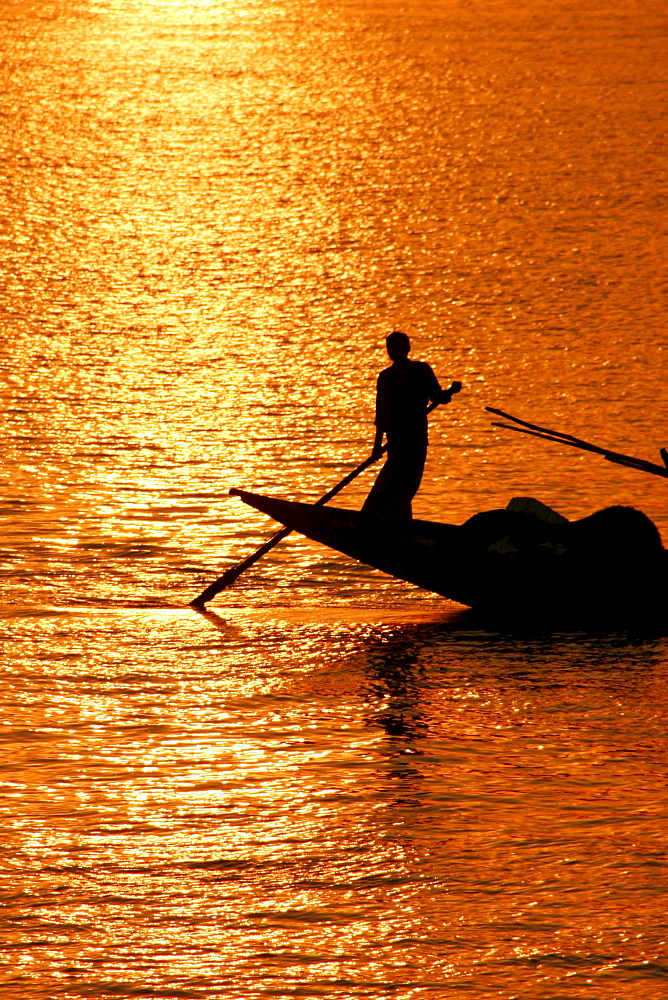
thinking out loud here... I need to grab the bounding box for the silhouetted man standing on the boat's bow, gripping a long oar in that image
[362,330,461,518]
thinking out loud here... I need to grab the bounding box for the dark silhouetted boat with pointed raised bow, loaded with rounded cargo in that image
[230,490,668,618]
